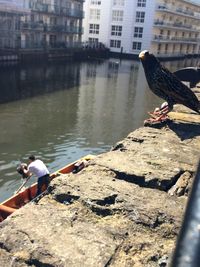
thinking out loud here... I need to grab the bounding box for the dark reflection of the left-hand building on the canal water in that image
[0,63,80,103]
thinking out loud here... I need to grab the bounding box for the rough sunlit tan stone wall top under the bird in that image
[0,88,200,267]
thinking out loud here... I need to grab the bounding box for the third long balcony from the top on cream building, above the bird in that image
[152,35,200,44]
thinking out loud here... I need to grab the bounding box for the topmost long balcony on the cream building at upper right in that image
[156,4,200,20]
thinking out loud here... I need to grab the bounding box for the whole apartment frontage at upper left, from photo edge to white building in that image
[0,0,84,49]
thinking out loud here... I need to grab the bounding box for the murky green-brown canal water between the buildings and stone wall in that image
[0,59,198,201]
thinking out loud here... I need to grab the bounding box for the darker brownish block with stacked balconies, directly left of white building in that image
[21,0,84,48]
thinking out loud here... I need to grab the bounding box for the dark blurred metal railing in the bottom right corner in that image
[170,163,200,267]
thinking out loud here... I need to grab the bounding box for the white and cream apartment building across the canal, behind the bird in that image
[83,0,200,57]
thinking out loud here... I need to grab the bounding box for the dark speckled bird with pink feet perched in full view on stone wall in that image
[139,50,200,122]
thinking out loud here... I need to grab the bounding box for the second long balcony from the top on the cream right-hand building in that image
[154,20,200,32]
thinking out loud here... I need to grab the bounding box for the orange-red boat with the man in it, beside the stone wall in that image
[0,155,94,222]
